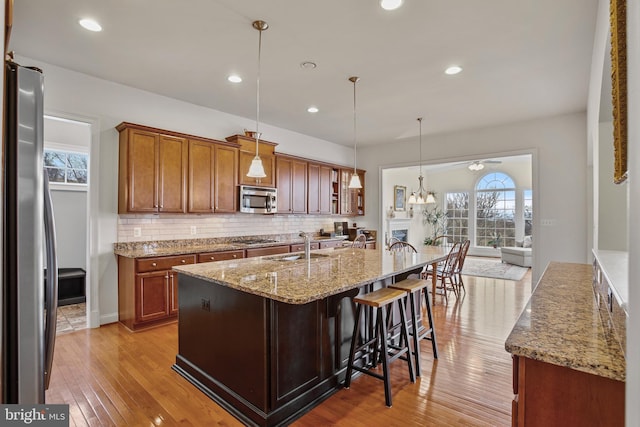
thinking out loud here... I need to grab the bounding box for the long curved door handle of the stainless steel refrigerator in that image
[43,170,58,390]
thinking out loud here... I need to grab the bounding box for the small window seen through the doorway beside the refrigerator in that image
[44,148,89,185]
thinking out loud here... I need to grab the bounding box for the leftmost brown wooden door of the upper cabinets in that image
[127,129,159,212]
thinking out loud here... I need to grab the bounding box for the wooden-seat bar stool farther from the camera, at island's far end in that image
[389,278,438,376]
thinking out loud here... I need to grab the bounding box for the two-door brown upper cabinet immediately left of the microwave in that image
[188,140,238,213]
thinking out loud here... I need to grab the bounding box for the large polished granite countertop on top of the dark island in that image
[173,247,446,304]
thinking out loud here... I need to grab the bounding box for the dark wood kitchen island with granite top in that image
[173,247,444,426]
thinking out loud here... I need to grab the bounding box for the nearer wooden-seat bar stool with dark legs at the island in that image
[344,288,416,407]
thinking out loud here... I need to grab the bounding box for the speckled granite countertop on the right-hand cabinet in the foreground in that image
[505,262,626,381]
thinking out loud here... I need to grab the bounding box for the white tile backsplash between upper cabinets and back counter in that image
[118,214,366,242]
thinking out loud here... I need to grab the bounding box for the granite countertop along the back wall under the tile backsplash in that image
[113,235,347,258]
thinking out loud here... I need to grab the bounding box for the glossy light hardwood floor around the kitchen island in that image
[47,271,531,427]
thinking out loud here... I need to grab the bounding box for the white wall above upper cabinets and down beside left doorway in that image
[16,57,366,324]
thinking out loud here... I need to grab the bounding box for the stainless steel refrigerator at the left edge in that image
[0,61,58,404]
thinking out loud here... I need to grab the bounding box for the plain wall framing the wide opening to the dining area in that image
[358,113,591,283]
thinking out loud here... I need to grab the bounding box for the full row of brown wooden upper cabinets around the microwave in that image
[116,122,365,216]
